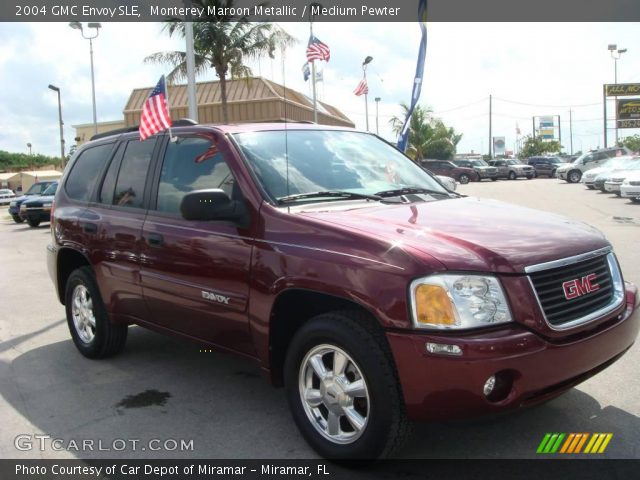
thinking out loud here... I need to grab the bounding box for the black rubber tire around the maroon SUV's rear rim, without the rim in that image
[65,267,128,358]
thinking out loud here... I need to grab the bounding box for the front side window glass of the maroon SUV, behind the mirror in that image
[156,137,235,213]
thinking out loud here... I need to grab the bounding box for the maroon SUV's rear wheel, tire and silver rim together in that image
[65,267,128,358]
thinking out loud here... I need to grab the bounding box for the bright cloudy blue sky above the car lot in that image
[0,23,640,155]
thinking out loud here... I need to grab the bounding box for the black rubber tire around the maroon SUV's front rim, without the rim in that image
[284,311,410,460]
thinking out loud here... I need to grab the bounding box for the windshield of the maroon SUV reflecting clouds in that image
[234,130,447,201]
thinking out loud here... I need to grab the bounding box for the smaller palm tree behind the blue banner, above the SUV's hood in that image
[389,103,462,160]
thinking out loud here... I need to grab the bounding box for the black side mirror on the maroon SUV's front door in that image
[180,188,249,228]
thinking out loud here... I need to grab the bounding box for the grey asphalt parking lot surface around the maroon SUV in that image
[0,179,640,459]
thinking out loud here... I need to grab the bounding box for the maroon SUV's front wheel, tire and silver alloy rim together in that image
[284,311,409,460]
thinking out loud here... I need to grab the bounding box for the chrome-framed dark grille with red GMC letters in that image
[528,249,624,329]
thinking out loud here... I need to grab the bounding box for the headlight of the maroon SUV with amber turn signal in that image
[410,275,512,329]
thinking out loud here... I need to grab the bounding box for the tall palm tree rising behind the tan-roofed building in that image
[144,0,295,123]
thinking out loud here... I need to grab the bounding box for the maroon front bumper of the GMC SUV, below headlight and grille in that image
[387,283,640,420]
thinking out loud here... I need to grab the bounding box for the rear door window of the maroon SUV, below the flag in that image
[113,139,155,208]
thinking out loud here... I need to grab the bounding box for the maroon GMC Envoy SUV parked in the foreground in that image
[48,124,640,458]
